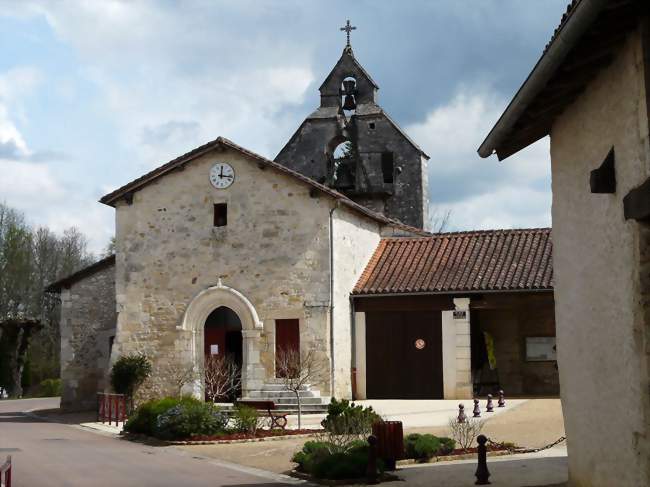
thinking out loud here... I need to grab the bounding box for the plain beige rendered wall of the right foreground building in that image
[551,27,650,487]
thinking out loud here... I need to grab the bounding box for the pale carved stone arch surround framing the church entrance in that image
[181,281,266,398]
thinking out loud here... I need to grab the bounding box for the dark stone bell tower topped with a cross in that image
[275,20,429,228]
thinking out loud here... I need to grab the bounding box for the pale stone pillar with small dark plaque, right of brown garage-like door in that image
[453,298,474,399]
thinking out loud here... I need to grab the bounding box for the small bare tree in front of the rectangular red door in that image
[275,349,327,429]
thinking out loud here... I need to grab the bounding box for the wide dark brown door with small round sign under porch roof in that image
[366,310,443,399]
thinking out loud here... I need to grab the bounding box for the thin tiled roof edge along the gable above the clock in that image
[99,137,429,235]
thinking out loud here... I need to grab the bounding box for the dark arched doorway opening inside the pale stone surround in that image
[203,306,243,400]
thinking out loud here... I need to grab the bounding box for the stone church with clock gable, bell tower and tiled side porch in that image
[47,27,559,410]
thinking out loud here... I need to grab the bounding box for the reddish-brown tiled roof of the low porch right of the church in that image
[353,228,553,295]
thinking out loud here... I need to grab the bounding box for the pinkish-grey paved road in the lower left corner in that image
[0,399,304,487]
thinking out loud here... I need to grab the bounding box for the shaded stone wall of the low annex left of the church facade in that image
[61,265,117,411]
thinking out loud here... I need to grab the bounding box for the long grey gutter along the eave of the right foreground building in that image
[478,0,609,160]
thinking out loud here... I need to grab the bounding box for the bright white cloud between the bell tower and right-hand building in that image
[407,87,551,229]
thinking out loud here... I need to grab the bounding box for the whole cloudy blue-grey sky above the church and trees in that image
[0,0,567,253]
